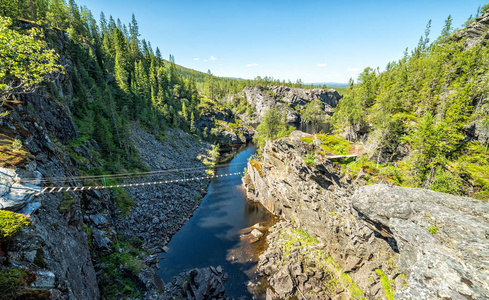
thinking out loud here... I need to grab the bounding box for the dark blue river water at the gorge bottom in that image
[158,145,272,299]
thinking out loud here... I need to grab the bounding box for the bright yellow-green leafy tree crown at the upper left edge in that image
[0,16,62,106]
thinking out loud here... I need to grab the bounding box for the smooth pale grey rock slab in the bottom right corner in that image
[351,185,489,299]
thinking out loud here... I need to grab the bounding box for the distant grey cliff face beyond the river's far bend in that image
[241,86,343,123]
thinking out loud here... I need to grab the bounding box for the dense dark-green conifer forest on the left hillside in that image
[0,0,324,176]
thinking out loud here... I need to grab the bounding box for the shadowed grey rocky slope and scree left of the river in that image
[0,95,223,299]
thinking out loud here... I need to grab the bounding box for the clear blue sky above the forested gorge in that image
[77,0,487,82]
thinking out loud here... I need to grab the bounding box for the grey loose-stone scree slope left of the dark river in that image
[115,124,215,253]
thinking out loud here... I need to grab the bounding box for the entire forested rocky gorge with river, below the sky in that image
[0,0,489,300]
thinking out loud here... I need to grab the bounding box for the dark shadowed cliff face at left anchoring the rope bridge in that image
[0,95,99,299]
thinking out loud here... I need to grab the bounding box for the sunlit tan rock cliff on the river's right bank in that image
[244,131,489,299]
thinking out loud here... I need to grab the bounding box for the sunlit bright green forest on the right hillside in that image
[333,5,489,199]
